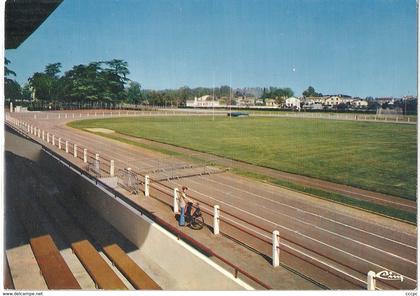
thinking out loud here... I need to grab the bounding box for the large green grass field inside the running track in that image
[70,116,417,200]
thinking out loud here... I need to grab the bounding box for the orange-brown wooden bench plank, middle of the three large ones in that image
[71,240,127,290]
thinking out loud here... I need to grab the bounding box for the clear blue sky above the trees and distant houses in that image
[6,0,417,97]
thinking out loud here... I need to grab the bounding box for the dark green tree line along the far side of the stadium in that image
[5,59,293,107]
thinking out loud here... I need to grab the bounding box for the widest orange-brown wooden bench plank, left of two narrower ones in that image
[30,235,80,290]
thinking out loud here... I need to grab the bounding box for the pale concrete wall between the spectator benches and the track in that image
[6,126,252,290]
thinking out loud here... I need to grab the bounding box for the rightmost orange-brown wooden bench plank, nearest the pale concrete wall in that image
[103,244,161,290]
